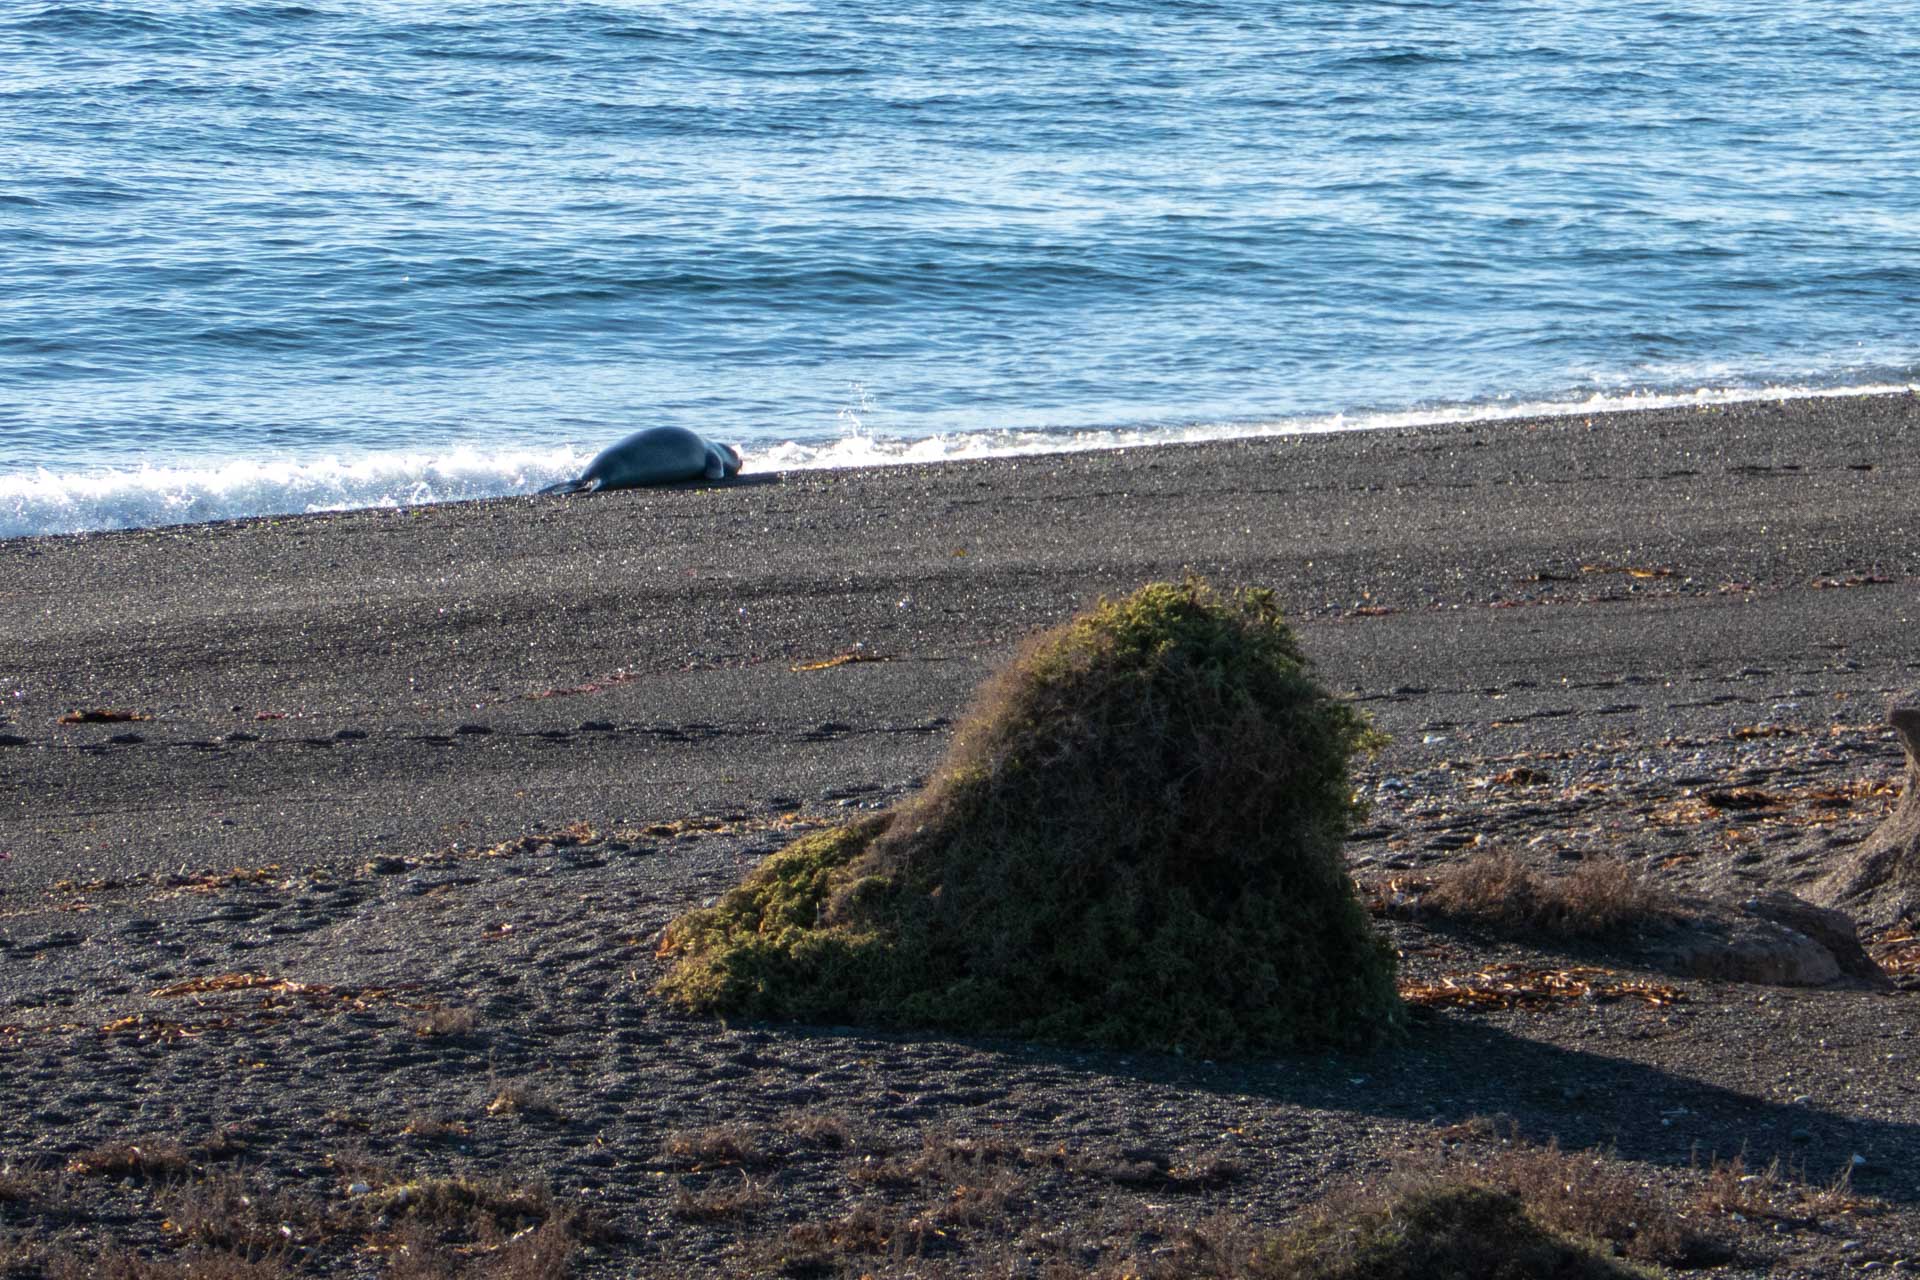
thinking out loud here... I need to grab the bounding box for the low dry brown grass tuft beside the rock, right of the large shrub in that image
[1419,848,1674,938]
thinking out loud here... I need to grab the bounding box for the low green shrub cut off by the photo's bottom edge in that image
[1252,1184,1659,1280]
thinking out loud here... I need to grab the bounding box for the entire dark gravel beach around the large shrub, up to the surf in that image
[0,395,1920,1276]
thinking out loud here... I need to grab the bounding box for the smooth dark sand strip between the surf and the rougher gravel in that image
[0,395,1920,885]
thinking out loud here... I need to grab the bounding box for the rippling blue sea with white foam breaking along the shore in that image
[0,0,1920,535]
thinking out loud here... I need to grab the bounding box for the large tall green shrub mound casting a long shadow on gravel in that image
[660,580,1402,1054]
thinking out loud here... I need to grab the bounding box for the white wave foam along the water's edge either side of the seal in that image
[0,384,1920,537]
